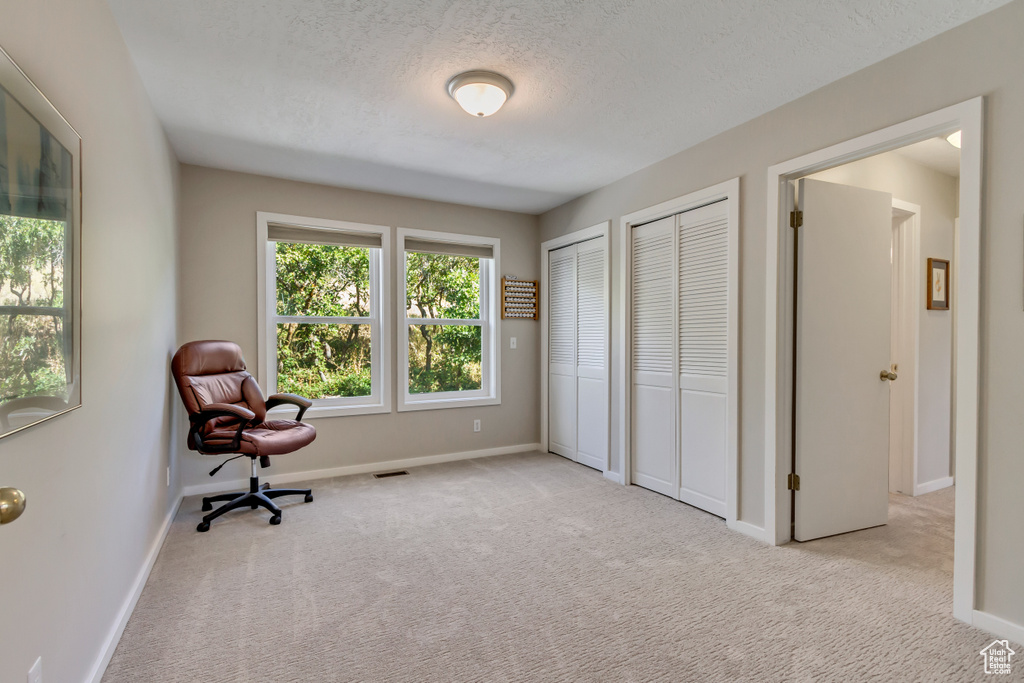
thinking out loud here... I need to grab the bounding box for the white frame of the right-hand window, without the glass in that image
[395,227,502,412]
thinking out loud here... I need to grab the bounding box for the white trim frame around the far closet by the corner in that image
[538,220,617,473]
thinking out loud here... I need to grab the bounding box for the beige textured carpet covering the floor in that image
[103,453,1024,683]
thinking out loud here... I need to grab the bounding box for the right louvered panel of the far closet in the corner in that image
[575,238,608,471]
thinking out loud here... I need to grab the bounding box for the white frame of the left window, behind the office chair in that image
[256,211,391,418]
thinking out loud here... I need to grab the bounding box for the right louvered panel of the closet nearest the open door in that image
[677,202,730,517]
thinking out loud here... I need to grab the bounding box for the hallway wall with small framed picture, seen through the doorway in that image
[811,152,959,485]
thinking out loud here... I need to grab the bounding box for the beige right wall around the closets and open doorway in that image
[541,0,1024,625]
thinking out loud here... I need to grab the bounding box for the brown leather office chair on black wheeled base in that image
[171,341,316,531]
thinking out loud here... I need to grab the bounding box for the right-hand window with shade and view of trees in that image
[397,229,501,411]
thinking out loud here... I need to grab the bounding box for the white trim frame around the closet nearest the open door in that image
[605,178,741,528]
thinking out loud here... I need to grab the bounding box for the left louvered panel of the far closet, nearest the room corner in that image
[548,245,577,460]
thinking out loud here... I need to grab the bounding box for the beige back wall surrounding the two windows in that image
[179,165,540,485]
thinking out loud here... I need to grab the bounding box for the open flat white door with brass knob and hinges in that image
[794,179,892,541]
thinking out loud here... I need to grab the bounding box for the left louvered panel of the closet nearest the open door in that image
[631,217,678,498]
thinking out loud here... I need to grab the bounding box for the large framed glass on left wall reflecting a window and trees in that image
[0,48,82,437]
